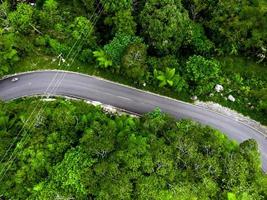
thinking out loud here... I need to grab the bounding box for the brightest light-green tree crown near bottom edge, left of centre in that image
[31,147,94,199]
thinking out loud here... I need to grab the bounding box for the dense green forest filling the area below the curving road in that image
[0,99,267,200]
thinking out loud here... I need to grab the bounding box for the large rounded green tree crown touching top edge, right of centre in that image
[140,0,189,54]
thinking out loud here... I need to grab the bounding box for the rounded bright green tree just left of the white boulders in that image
[184,56,220,95]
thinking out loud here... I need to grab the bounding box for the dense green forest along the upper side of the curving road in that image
[0,0,267,124]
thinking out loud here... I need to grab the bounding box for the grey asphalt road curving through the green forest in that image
[0,71,267,172]
